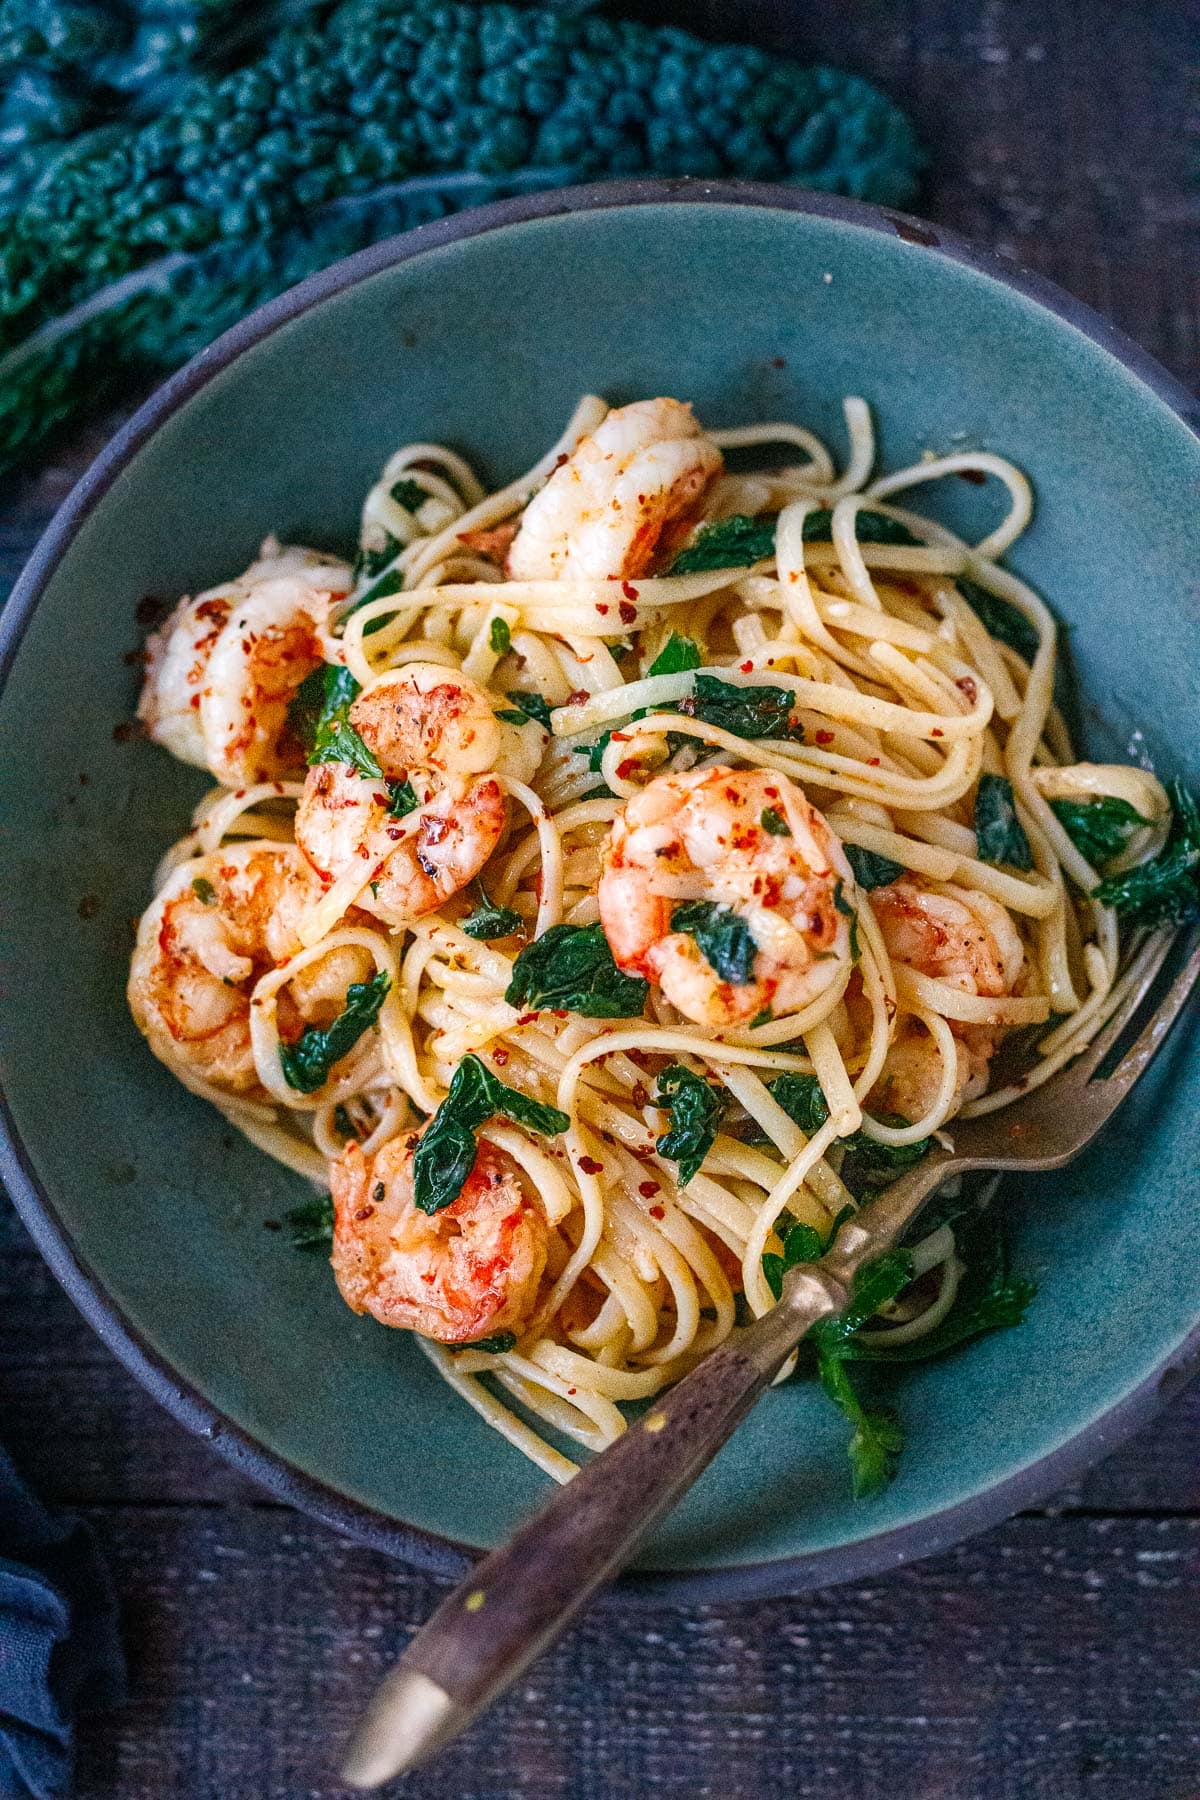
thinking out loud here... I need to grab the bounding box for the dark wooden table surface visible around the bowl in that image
[0,0,1200,1800]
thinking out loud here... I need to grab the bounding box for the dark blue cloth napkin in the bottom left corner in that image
[0,1449,124,1800]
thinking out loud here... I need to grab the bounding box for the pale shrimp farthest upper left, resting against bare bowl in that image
[137,538,351,787]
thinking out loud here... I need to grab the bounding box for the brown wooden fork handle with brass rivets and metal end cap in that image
[342,1267,847,1787]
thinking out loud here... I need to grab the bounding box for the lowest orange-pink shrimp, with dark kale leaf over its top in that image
[329,1132,549,1345]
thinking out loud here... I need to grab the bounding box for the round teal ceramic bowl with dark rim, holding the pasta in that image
[0,184,1200,1598]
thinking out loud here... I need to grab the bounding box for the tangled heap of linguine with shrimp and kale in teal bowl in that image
[131,396,1169,1480]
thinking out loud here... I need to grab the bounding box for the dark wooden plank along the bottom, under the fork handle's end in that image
[79,1508,1200,1800]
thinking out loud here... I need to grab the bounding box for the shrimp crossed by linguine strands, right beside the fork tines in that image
[871,877,1025,1120]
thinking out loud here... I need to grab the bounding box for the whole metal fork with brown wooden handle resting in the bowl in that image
[342,931,1200,1787]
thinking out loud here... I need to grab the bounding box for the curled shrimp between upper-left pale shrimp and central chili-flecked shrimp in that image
[295,662,545,923]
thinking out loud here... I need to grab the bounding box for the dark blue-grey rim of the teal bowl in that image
[0,176,1200,1606]
